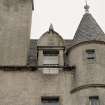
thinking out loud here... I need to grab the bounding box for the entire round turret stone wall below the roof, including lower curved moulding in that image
[69,43,105,105]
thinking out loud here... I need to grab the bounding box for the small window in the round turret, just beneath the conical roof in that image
[86,49,96,63]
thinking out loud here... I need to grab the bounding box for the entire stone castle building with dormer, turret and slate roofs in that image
[0,0,105,105]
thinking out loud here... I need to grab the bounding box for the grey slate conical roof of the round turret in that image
[74,13,105,40]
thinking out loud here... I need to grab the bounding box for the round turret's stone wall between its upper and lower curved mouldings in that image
[69,43,105,87]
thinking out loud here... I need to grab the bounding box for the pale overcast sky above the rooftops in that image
[31,0,105,39]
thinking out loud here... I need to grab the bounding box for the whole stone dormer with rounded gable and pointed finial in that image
[37,25,64,74]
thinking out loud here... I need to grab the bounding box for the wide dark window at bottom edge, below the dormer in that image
[41,97,59,105]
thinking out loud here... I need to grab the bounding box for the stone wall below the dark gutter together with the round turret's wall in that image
[0,43,105,105]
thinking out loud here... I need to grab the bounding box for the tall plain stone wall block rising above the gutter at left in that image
[0,0,32,65]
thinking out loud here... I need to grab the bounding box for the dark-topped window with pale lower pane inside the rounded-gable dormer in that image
[43,50,59,66]
